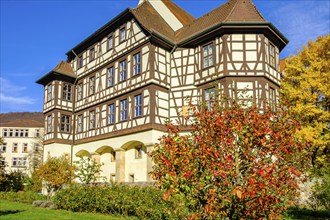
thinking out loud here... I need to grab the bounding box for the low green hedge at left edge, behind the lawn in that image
[0,191,46,204]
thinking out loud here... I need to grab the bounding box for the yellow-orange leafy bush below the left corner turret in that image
[36,155,76,196]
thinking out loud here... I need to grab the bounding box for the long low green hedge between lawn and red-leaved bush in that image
[53,185,187,219]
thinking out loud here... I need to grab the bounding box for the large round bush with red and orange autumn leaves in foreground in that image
[152,100,306,219]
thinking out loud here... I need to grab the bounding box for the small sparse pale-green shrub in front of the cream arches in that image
[75,157,103,184]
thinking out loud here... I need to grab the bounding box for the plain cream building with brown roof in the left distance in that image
[0,112,44,174]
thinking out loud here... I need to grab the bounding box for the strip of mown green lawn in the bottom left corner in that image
[0,200,133,220]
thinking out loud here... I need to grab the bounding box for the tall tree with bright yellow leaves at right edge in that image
[281,34,330,172]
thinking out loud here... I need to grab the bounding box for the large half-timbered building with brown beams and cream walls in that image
[37,0,288,182]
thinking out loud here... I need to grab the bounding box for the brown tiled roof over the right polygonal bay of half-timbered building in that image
[176,0,266,42]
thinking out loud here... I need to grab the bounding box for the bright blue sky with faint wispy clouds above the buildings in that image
[0,0,330,113]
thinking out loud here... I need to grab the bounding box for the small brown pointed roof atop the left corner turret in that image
[37,61,76,85]
